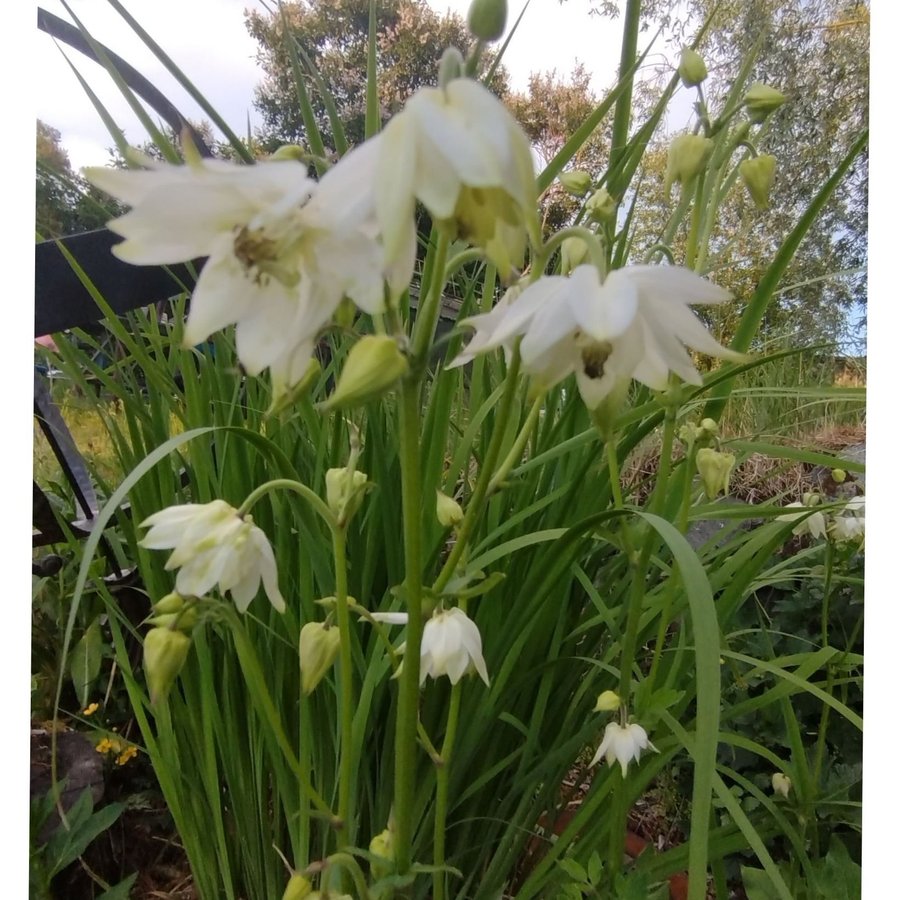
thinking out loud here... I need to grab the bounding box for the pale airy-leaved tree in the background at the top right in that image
[590,0,869,352]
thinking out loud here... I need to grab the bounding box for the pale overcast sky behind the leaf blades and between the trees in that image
[34,0,687,169]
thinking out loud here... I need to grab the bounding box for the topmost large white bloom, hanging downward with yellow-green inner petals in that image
[375,78,540,278]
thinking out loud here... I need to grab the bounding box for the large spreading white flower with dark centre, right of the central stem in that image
[452,265,743,409]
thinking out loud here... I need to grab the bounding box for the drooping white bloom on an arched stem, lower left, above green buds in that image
[140,500,285,612]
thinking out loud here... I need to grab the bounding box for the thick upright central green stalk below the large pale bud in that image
[394,378,426,875]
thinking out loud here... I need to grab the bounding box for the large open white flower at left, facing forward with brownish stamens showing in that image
[86,145,406,394]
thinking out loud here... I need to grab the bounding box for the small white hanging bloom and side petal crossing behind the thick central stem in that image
[372,607,490,686]
